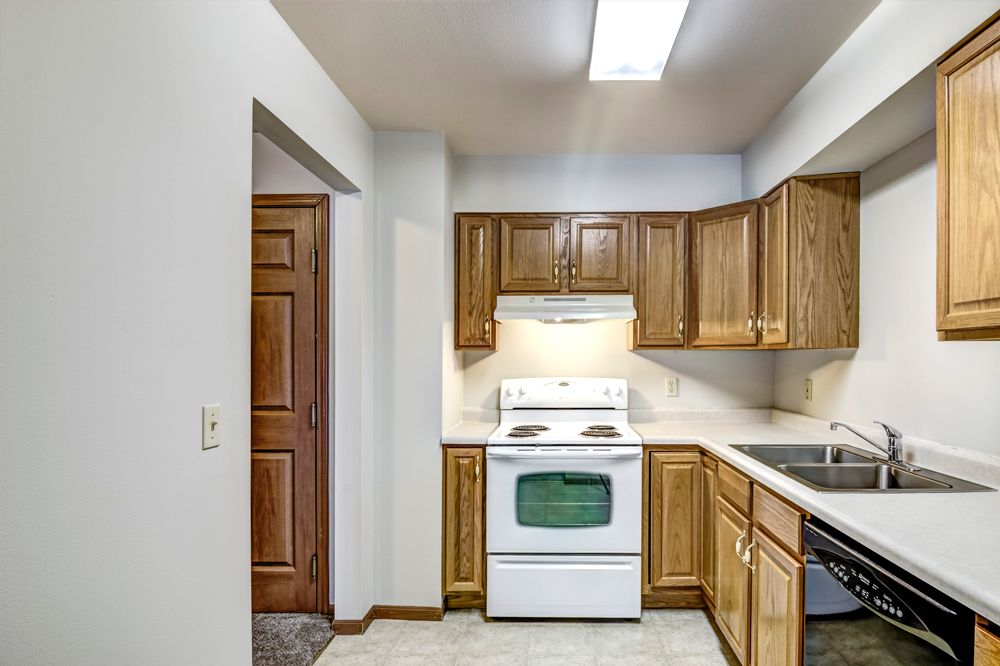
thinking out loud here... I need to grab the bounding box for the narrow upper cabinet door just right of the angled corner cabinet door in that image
[757,183,789,345]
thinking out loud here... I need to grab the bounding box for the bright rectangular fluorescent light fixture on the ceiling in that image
[590,0,688,81]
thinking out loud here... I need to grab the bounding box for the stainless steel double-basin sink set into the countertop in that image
[733,444,993,493]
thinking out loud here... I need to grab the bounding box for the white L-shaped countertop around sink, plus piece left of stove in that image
[441,412,1000,622]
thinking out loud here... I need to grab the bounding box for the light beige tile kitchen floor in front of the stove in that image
[316,609,736,666]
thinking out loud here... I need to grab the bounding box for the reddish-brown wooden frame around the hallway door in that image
[251,194,333,615]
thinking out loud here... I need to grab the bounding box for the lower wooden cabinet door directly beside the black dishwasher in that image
[752,530,805,666]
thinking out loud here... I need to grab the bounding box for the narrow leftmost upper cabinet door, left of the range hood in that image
[455,216,496,349]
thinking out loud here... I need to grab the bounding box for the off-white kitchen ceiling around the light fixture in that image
[272,0,878,155]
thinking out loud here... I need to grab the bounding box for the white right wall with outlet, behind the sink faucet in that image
[774,133,1000,455]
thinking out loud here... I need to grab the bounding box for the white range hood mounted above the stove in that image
[493,294,636,324]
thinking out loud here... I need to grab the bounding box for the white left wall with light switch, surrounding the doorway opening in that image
[0,1,372,666]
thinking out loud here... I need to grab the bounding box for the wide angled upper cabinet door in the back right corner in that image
[690,202,757,347]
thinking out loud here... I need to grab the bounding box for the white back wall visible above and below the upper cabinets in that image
[454,155,772,410]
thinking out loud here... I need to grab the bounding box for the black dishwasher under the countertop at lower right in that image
[803,519,975,666]
